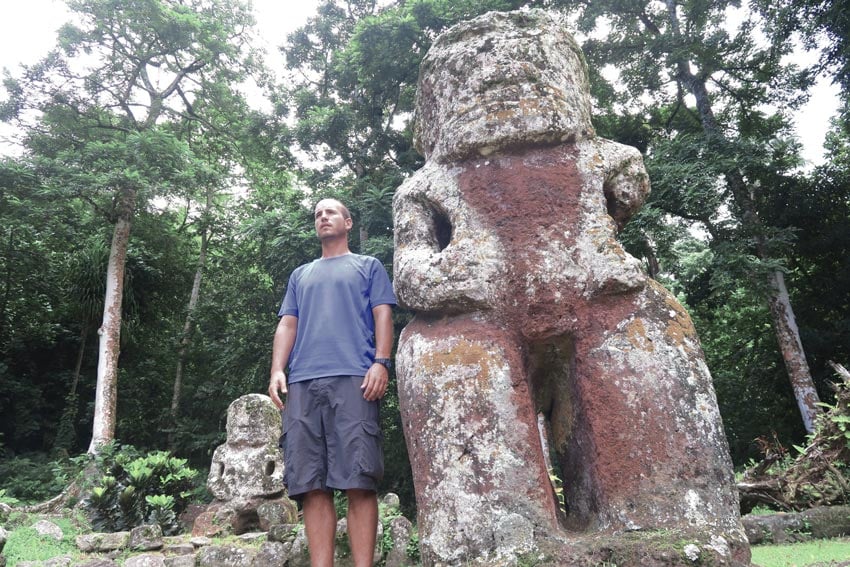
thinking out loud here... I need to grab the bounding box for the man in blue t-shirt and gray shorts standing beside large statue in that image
[269,199,396,567]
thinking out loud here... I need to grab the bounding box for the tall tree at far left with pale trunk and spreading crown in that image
[5,0,253,452]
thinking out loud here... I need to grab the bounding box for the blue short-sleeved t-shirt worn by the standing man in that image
[278,254,396,384]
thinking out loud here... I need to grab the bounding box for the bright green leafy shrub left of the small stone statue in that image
[84,444,198,534]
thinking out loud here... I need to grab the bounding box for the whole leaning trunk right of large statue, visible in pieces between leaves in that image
[666,0,819,433]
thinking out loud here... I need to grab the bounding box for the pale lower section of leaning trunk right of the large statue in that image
[768,270,820,433]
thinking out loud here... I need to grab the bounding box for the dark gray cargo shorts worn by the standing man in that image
[280,376,384,500]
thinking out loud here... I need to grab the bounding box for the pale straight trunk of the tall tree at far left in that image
[88,189,136,454]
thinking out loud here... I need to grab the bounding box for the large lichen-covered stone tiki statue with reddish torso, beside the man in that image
[393,11,749,565]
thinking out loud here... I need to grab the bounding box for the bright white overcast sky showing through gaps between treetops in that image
[0,0,838,164]
